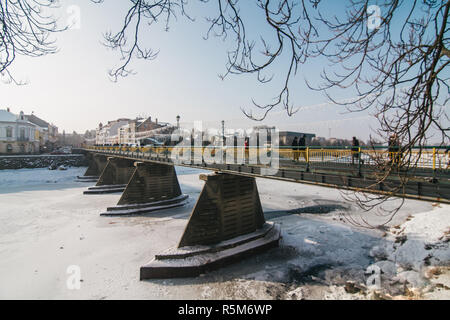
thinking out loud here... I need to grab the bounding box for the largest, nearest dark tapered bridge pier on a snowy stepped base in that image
[140,173,280,280]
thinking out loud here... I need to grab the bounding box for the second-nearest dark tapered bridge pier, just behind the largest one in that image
[101,162,188,216]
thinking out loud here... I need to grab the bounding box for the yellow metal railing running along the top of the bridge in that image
[89,146,450,170]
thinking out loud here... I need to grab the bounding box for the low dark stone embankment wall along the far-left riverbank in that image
[0,154,88,170]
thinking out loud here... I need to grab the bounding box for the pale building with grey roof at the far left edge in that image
[0,109,39,154]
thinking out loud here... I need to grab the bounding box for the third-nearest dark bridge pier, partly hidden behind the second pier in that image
[84,157,134,194]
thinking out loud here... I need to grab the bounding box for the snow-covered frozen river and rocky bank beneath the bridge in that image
[0,168,450,299]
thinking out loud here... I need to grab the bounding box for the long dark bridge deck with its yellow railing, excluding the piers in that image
[85,147,450,203]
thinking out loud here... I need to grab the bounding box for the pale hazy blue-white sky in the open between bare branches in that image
[0,0,446,140]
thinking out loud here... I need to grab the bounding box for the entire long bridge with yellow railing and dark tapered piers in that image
[79,146,450,279]
